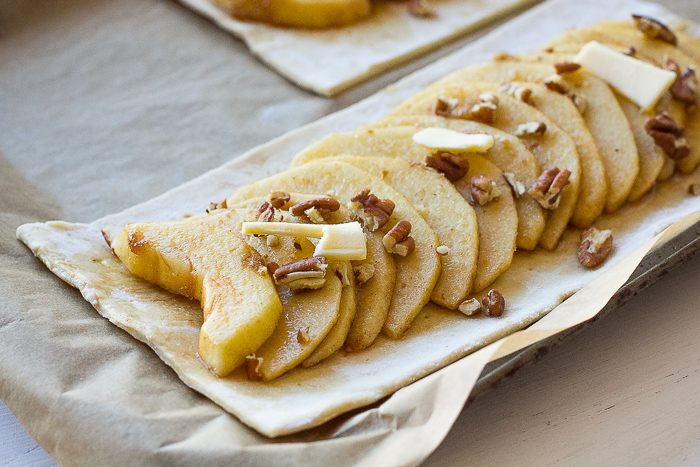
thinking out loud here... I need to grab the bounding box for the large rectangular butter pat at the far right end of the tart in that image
[574,41,676,110]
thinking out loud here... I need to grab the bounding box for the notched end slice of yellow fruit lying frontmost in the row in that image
[113,211,282,376]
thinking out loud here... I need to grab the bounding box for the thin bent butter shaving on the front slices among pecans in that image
[242,222,367,261]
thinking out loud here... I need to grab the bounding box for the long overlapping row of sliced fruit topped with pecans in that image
[108,12,700,381]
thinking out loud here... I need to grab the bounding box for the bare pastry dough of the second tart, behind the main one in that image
[179,0,539,96]
